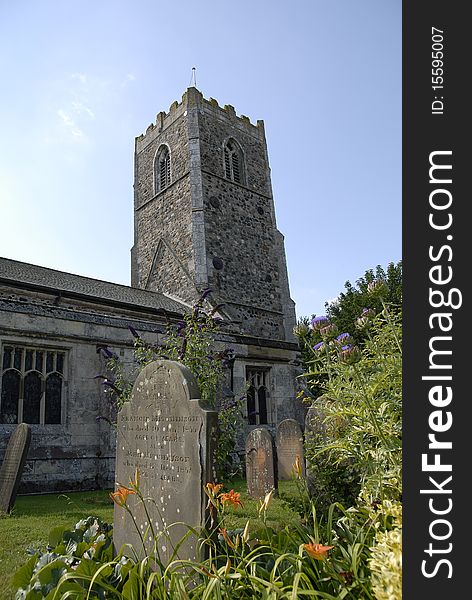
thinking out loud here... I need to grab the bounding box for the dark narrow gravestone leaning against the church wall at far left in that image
[0,423,31,513]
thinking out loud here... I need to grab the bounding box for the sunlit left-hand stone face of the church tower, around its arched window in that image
[132,104,195,302]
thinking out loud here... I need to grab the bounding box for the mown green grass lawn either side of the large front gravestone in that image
[0,480,299,600]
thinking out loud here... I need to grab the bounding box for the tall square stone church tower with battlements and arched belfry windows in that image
[131,87,296,341]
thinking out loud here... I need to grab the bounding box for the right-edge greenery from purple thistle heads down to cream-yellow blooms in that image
[298,279,402,600]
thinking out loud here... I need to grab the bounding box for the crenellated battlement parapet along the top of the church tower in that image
[136,87,264,142]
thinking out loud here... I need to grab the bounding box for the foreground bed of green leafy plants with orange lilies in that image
[15,478,388,600]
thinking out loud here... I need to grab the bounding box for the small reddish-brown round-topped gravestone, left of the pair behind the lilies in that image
[246,427,277,498]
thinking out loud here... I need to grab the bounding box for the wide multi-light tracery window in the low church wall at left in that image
[0,345,66,425]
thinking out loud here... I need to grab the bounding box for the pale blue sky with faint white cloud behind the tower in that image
[0,0,401,316]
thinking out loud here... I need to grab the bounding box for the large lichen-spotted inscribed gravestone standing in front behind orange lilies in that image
[113,360,217,565]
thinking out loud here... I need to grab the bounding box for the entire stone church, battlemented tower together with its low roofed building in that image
[0,87,303,492]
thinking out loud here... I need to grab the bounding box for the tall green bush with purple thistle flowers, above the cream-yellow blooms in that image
[296,282,402,503]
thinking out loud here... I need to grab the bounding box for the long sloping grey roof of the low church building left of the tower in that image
[0,257,189,314]
